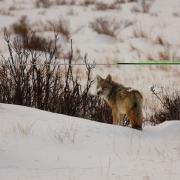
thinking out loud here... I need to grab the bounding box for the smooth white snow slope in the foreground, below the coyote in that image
[0,104,180,180]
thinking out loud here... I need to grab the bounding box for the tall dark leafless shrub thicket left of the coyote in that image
[0,31,112,123]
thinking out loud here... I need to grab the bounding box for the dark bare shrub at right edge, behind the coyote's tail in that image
[145,85,180,125]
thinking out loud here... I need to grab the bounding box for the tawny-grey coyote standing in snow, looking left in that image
[96,74,143,130]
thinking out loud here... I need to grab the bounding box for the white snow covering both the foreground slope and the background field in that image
[0,0,180,180]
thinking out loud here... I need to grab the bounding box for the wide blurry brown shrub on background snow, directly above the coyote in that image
[89,17,133,38]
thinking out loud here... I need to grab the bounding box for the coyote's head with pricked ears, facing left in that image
[96,74,112,96]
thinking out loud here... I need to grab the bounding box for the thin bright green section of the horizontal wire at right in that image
[117,62,180,65]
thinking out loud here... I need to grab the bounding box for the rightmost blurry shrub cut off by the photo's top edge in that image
[131,0,153,13]
